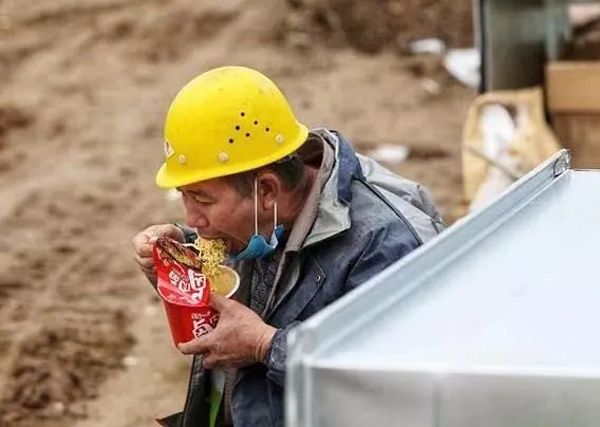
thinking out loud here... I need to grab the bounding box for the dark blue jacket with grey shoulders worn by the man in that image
[162,129,444,427]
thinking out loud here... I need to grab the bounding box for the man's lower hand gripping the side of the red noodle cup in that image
[178,293,277,369]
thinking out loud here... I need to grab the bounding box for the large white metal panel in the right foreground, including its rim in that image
[286,152,600,427]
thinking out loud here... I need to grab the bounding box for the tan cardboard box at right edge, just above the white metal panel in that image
[546,61,600,168]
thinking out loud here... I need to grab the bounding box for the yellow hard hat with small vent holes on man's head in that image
[156,67,308,188]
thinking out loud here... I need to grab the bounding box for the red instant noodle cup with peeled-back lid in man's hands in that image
[153,239,240,345]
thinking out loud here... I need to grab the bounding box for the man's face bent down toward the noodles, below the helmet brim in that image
[179,178,260,252]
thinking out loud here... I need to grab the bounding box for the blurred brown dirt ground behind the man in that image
[0,0,474,427]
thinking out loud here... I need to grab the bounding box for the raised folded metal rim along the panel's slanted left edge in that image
[285,150,570,427]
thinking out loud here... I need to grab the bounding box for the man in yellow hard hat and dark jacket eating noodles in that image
[133,67,444,427]
